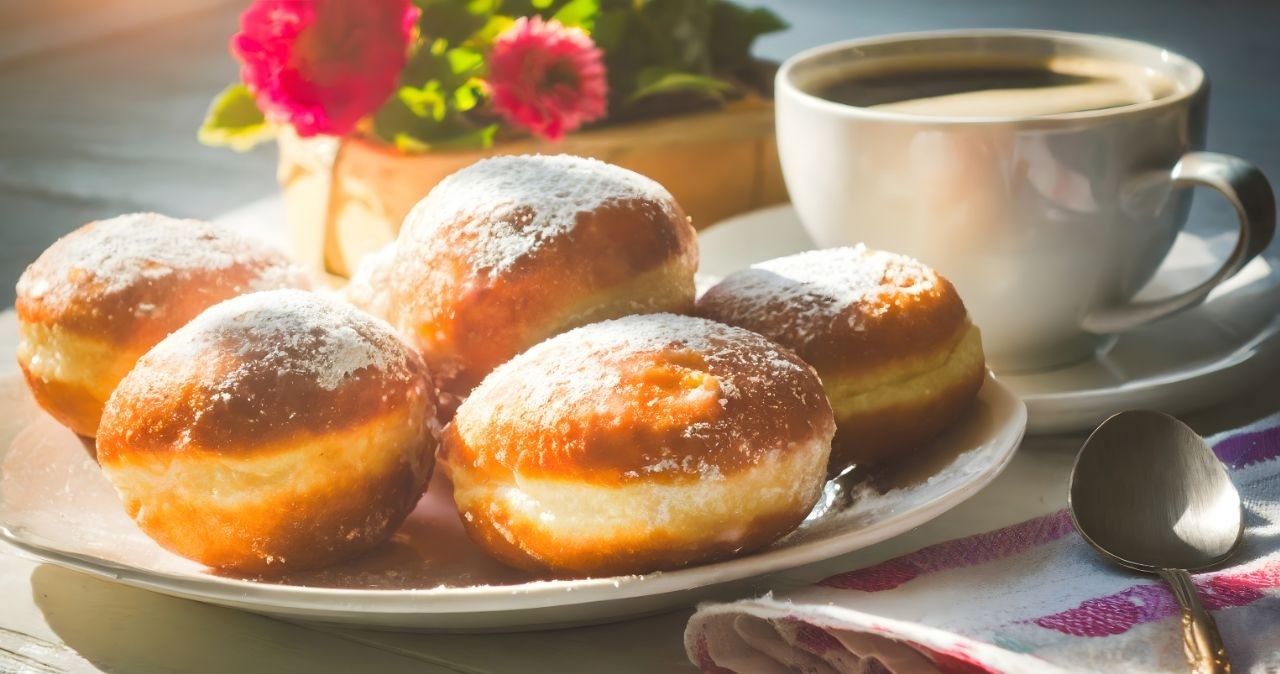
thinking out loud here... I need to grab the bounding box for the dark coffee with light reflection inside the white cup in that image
[815,59,1174,116]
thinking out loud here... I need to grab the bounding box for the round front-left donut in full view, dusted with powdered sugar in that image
[97,290,439,574]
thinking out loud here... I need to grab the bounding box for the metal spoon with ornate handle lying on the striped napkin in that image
[1068,411,1244,674]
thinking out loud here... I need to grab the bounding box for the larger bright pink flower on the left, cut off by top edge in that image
[232,0,417,136]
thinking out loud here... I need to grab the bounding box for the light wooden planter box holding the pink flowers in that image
[278,98,787,278]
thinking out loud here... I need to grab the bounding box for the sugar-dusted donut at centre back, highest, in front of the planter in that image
[389,155,698,404]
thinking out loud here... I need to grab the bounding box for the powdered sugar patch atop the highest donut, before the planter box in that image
[402,155,676,274]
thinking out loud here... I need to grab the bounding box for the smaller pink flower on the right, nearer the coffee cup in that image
[489,17,608,141]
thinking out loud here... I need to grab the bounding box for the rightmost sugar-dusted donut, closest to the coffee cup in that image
[698,246,986,473]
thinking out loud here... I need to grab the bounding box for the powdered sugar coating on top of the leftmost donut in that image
[18,212,306,298]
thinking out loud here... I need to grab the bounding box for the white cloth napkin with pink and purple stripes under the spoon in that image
[685,416,1280,674]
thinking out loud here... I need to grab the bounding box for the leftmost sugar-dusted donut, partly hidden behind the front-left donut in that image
[17,214,307,437]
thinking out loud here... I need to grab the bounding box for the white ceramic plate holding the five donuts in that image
[0,377,1027,631]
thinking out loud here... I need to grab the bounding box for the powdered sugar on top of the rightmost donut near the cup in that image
[699,244,938,347]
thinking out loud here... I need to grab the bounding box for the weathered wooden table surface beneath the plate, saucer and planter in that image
[0,0,1280,674]
